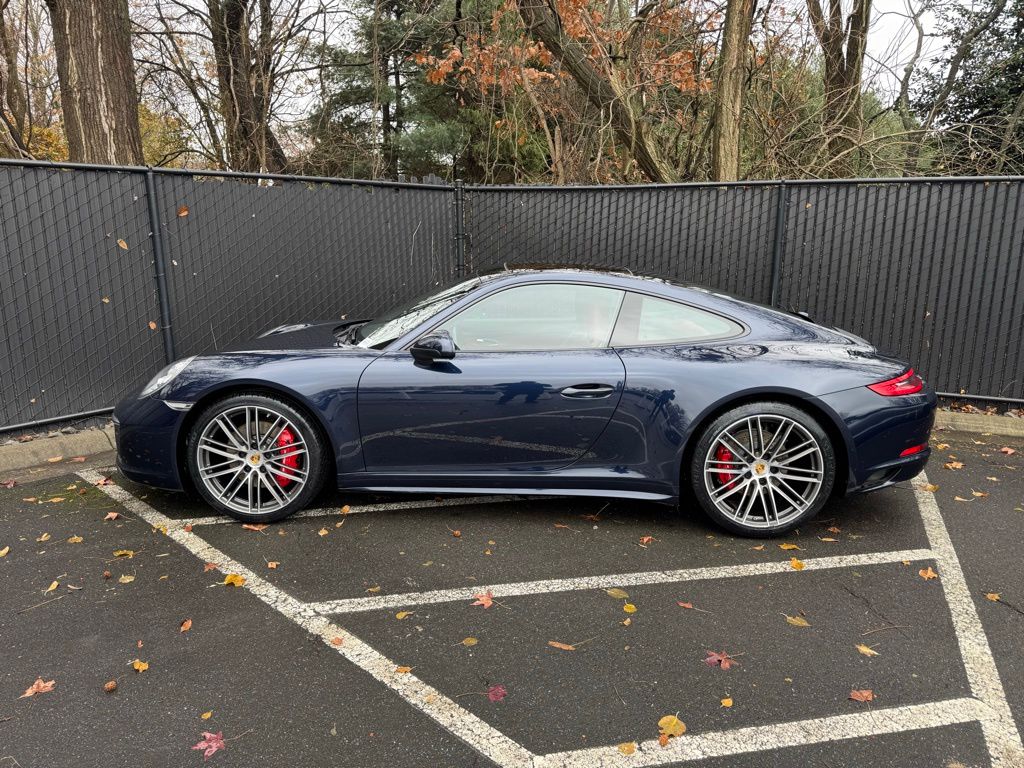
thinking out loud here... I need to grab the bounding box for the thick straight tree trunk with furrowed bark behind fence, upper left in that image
[46,0,144,165]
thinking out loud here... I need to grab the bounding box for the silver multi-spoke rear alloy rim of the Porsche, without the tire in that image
[703,414,824,528]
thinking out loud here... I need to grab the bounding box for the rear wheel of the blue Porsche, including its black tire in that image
[685,400,837,539]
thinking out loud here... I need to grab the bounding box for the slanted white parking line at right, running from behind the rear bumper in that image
[914,473,1024,768]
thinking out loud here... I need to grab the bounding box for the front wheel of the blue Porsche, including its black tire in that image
[186,394,327,522]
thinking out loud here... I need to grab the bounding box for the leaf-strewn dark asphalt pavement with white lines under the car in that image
[0,432,1024,768]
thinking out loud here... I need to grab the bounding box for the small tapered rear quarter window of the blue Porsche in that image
[611,293,743,347]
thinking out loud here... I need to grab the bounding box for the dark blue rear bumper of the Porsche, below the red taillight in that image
[821,387,937,494]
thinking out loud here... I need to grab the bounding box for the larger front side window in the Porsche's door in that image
[437,283,625,352]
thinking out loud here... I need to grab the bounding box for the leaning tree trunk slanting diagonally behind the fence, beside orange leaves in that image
[516,0,677,182]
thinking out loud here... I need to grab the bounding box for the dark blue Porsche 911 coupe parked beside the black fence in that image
[115,269,936,537]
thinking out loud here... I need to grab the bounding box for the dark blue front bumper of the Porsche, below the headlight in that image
[114,396,186,490]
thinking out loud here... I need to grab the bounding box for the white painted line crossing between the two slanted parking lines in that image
[309,549,934,613]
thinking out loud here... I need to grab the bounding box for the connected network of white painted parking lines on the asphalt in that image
[78,470,1024,768]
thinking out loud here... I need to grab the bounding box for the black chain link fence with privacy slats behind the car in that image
[0,161,1024,430]
